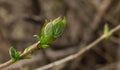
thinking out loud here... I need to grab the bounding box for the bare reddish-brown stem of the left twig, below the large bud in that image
[0,42,40,69]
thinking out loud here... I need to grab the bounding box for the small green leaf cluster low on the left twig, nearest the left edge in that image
[9,47,21,62]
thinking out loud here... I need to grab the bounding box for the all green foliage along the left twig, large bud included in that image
[9,17,66,62]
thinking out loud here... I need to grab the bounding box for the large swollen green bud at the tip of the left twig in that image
[34,17,66,48]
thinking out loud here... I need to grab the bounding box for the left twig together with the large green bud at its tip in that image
[0,17,66,69]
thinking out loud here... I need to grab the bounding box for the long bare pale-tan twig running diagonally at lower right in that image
[35,25,120,70]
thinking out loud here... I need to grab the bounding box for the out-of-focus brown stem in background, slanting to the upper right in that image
[70,0,111,70]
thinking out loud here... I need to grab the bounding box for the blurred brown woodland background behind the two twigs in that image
[0,0,120,70]
